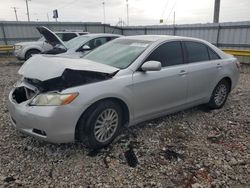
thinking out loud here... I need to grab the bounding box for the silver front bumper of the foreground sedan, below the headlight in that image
[8,81,78,143]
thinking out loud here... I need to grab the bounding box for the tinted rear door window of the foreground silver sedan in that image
[184,41,209,63]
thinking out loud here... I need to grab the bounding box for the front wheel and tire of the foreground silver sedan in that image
[77,101,123,149]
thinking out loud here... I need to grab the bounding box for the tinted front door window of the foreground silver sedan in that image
[146,41,183,67]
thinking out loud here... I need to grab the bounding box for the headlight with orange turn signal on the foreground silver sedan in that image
[30,93,78,106]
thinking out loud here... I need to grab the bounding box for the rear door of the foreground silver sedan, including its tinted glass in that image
[183,41,221,103]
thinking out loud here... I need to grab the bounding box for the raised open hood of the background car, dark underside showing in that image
[36,26,67,49]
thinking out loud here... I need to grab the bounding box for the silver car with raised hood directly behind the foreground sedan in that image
[37,27,121,58]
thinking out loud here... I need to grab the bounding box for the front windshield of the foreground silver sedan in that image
[84,39,150,69]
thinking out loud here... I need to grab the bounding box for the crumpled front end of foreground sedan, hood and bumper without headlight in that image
[8,55,119,143]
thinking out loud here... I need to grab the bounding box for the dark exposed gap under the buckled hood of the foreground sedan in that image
[12,69,118,104]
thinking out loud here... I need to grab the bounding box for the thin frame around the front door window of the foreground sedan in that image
[136,40,186,72]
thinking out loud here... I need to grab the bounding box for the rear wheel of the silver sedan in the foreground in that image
[208,80,230,109]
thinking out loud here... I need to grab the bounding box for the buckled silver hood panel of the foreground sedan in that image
[18,55,119,81]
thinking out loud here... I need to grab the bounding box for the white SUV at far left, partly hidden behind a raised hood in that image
[13,27,88,60]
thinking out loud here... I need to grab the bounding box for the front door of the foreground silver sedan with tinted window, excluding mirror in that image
[133,41,187,121]
